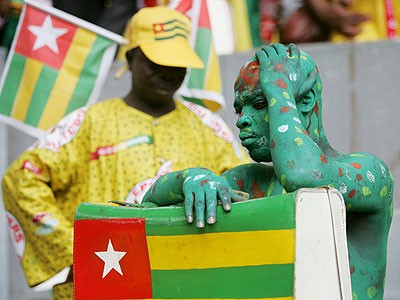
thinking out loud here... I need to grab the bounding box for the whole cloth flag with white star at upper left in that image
[0,0,124,137]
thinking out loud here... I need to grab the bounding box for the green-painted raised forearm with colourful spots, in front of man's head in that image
[269,90,325,191]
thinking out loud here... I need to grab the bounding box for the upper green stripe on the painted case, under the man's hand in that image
[75,193,296,236]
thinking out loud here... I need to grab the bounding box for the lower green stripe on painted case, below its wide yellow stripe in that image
[151,264,294,299]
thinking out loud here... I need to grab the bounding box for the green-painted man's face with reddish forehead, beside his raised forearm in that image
[234,62,272,162]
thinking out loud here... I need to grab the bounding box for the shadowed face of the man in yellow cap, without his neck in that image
[128,49,186,104]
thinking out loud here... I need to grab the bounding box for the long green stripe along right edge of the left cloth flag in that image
[65,36,113,114]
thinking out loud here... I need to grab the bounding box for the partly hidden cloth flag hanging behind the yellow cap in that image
[175,0,225,111]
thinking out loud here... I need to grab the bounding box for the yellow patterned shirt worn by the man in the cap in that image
[3,98,250,286]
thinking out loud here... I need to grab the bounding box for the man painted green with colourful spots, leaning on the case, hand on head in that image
[145,44,393,299]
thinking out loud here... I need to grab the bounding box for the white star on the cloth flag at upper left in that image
[28,15,68,53]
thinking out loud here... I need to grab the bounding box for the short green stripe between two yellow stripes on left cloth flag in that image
[24,65,58,127]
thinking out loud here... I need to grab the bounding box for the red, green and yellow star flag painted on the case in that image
[74,195,295,300]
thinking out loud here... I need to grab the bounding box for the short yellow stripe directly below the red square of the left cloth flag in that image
[11,58,43,121]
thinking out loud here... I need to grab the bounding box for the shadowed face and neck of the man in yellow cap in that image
[124,47,186,118]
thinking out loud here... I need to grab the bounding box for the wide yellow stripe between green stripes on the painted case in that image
[147,230,295,270]
